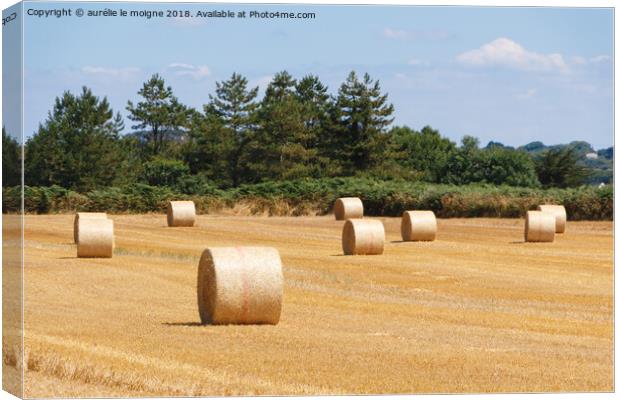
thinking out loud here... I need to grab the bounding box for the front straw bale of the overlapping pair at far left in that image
[77,218,114,258]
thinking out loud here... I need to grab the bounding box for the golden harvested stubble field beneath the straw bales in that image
[5,215,614,397]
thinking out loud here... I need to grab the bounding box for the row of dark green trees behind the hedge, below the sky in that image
[2,71,587,192]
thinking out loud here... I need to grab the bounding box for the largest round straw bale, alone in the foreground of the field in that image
[197,247,283,325]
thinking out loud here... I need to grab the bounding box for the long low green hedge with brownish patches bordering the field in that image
[2,178,613,220]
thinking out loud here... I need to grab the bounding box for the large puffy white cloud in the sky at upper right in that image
[456,37,569,72]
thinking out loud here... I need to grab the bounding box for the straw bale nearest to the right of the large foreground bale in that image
[342,219,385,255]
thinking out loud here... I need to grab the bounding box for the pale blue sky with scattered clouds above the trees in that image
[5,2,613,148]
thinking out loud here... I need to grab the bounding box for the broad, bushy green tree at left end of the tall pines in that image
[25,87,123,191]
